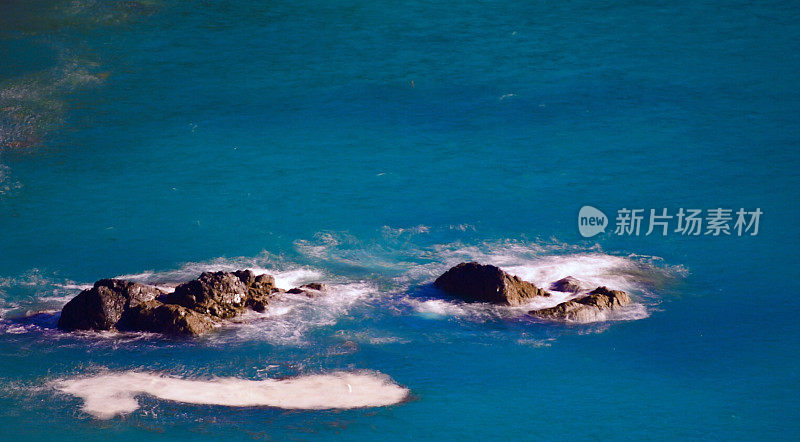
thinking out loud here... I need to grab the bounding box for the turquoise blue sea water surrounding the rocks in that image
[0,0,800,441]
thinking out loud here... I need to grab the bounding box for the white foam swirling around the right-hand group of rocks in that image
[397,242,686,322]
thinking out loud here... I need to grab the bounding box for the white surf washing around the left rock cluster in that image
[0,255,379,346]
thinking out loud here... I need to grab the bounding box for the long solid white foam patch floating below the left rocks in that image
[55,371,409,419]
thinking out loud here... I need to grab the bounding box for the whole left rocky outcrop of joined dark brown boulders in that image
[58,270,325,335]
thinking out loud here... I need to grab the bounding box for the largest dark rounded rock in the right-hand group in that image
[433,262,550,305]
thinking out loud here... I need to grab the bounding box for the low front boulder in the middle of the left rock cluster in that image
[118,300,214,335]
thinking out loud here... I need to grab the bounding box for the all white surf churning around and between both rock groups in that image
[0,231,687,338]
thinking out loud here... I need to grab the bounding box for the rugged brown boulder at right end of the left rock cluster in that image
[166,271,255,319]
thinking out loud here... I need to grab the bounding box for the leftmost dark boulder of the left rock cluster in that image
[58,279,163,331]
